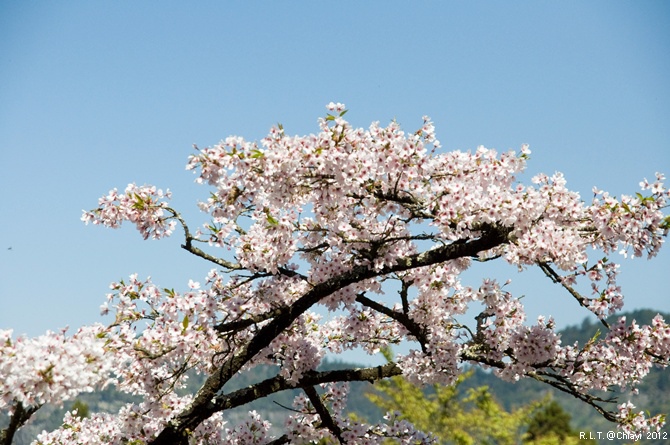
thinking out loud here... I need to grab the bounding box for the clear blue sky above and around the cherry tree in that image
[0,0,670,360]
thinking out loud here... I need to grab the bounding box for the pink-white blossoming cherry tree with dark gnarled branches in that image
[0,103,670,445]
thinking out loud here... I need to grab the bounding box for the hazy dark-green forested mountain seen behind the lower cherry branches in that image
[0,310,670,445]
